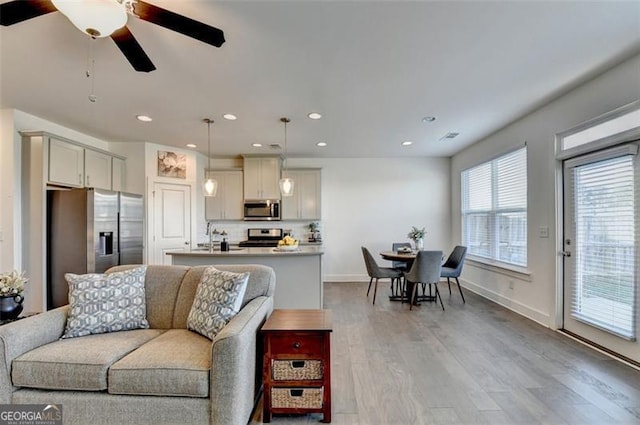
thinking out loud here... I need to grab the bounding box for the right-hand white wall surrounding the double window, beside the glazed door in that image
[451,52,640,328]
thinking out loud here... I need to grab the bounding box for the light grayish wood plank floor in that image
[251,283,640,425]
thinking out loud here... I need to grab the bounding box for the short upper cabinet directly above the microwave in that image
[244,156,280,199]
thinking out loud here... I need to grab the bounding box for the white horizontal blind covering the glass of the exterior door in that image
[570,155,637,339]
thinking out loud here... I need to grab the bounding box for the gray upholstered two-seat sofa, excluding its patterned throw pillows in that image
[0,265,275,425]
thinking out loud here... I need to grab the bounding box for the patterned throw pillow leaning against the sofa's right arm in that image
[187,267,249,340]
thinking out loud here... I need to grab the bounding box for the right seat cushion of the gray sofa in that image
[109,329,211,397]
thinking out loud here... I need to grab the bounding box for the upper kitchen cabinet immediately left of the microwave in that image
[204,170,244,220]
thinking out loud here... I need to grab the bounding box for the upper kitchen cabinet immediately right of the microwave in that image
[282,169,321,220]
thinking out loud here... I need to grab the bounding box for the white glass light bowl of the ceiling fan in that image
[51,0,127,38]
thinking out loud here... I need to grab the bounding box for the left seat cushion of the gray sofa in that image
[11,329,164,391]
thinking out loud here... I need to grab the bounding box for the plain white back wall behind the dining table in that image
[288,158,452,281]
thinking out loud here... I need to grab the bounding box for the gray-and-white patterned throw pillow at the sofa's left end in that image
[62,266,149,339]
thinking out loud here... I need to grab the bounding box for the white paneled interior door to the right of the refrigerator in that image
[152,183,191,264]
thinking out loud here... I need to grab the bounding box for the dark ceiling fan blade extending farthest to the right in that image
[133,0,225,47]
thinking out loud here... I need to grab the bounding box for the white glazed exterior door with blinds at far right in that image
[563,144,640,362]
